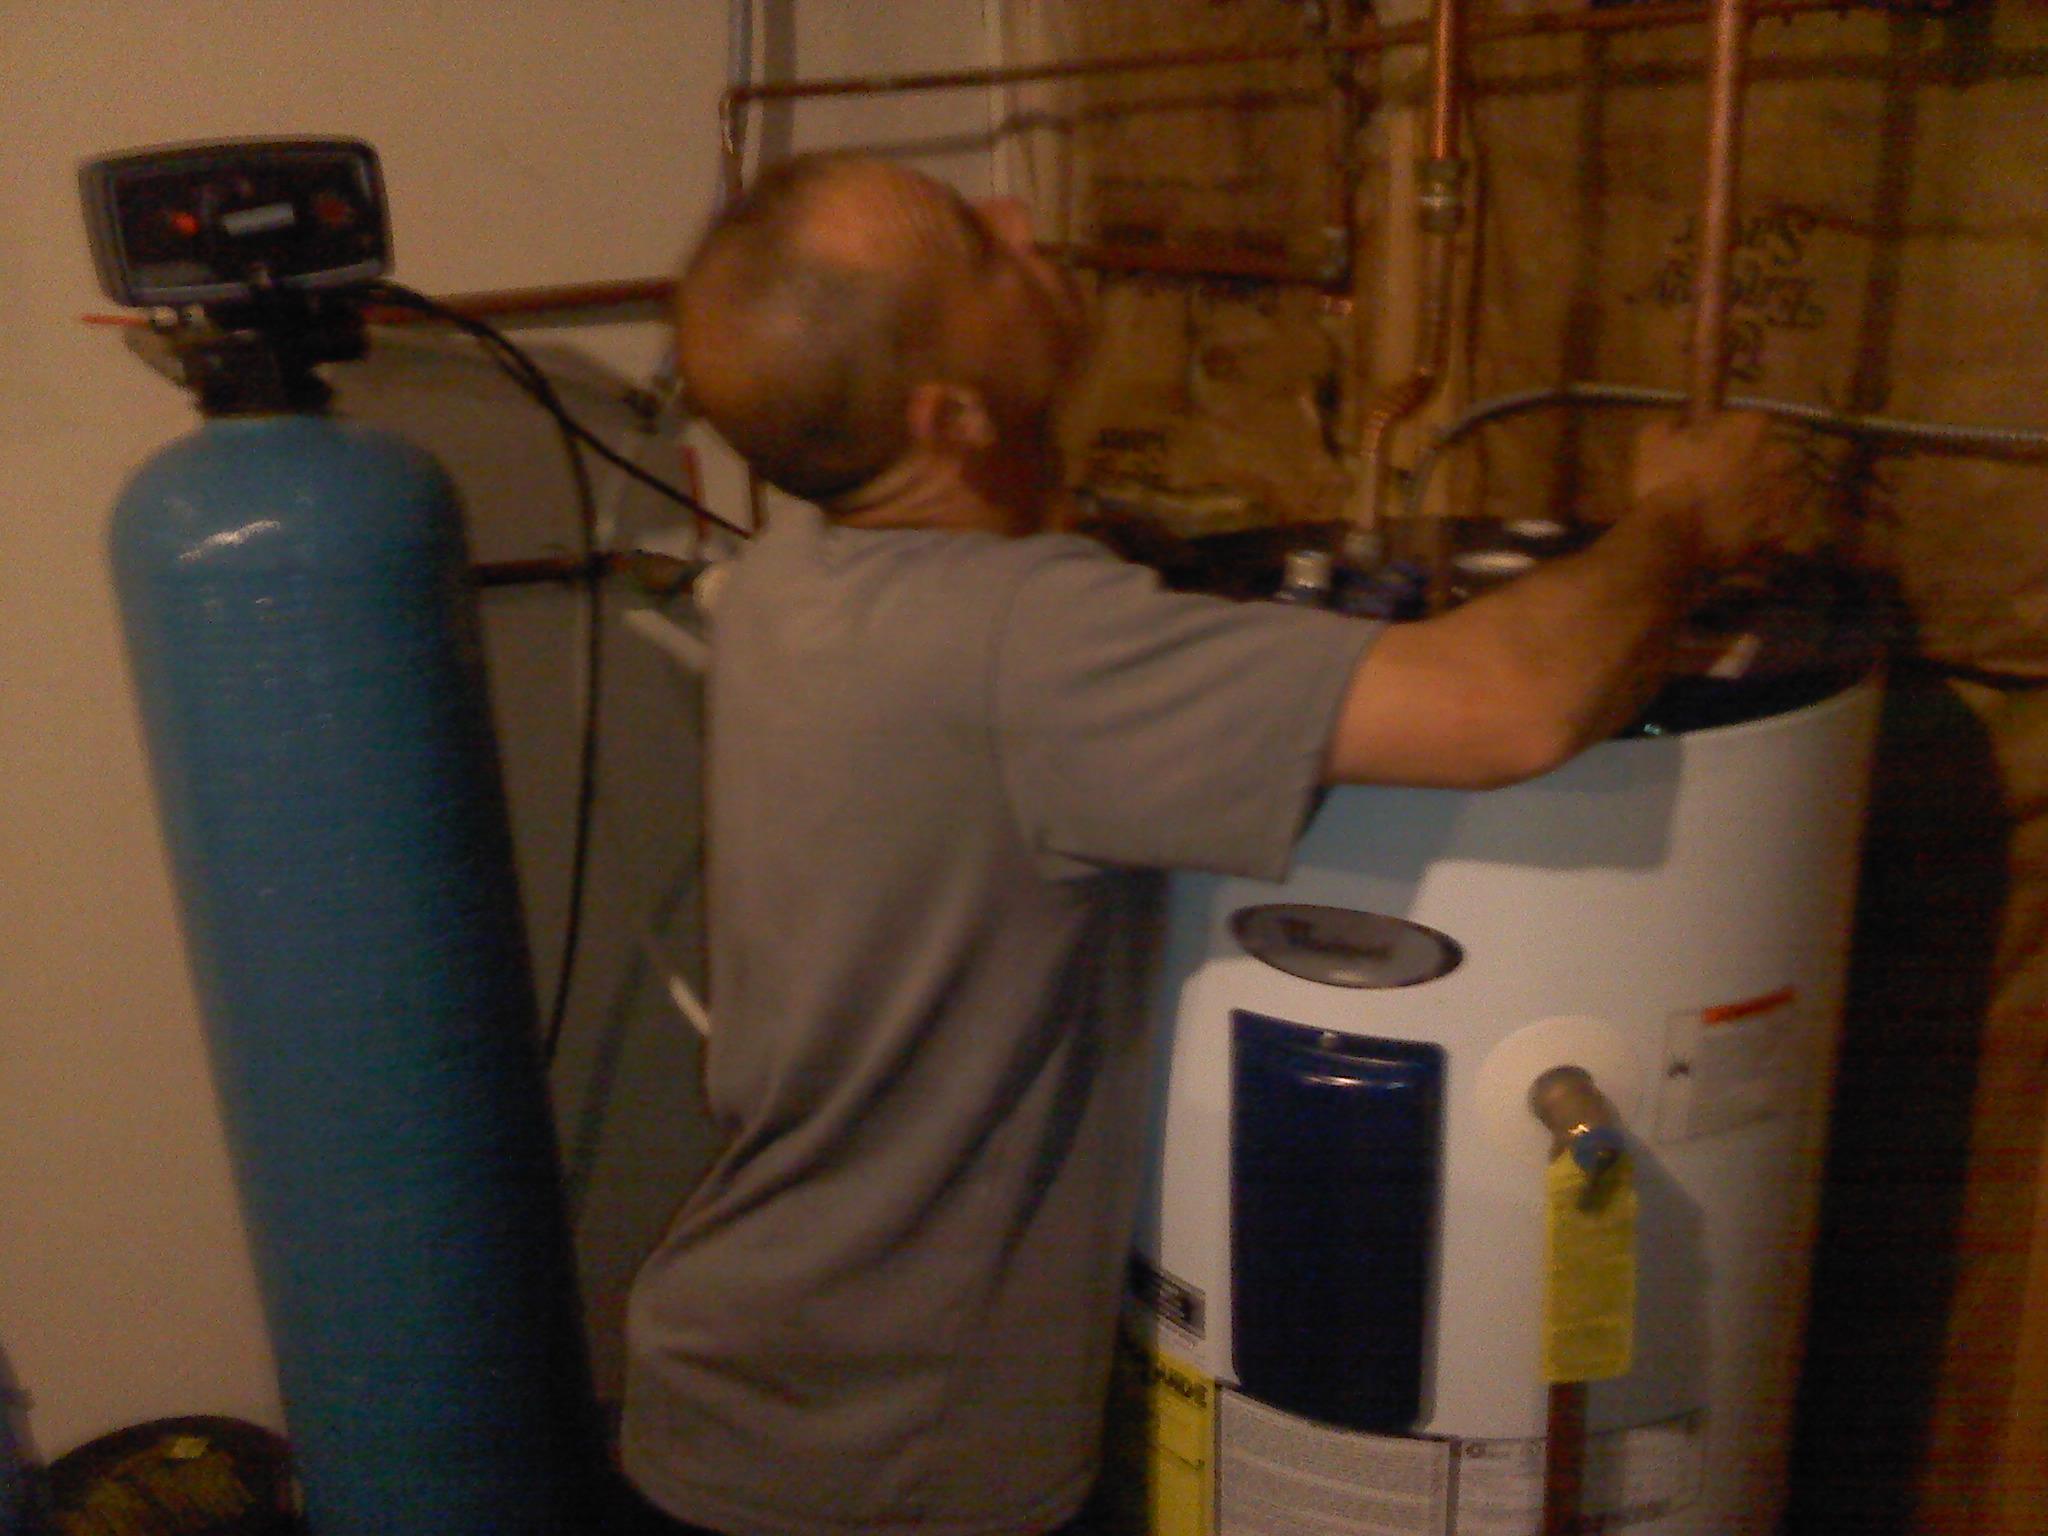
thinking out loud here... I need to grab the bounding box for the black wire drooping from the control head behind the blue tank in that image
[358,283,622,1063]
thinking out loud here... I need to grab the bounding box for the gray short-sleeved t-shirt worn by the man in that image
[625,508,1376,1536]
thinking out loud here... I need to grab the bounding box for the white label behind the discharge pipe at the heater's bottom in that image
[1450,1413,1704,1536]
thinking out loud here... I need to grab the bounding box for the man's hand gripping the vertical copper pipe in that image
[1630,412,1806,569]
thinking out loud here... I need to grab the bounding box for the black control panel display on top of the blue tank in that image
[78,139,391,305]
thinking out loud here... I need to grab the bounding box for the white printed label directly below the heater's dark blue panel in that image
[1217,1393,1450,1536]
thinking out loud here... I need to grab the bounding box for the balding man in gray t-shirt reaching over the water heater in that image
[623,147,1782,1536]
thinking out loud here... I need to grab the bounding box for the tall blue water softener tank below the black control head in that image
[113,410,594,1536]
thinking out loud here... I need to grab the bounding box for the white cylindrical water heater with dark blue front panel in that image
[1133,682,1876,1536]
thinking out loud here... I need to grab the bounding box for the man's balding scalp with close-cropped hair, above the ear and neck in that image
[676,156,975,502]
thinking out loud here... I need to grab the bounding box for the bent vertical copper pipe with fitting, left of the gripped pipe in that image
[1341,0,1464,565]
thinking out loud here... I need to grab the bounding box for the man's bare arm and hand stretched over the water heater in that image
[1323,416,1794,788]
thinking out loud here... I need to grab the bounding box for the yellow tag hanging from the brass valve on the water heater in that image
[1542,1153,1636,1382]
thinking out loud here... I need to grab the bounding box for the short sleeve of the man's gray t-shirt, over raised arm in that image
[991,539,1380,879]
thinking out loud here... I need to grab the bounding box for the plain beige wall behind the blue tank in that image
[0,0,987,1454]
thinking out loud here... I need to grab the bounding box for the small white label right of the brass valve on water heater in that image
[1657,987,1798,1141]
